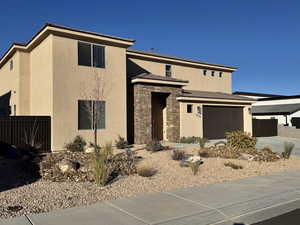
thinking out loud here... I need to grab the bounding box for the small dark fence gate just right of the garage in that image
[252,119,278,137]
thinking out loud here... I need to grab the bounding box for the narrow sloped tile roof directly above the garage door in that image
[181,90,253,101]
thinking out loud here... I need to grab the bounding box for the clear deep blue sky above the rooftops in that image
[0,0,300,95]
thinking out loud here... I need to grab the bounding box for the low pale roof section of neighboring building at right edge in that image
[252,103,300,115]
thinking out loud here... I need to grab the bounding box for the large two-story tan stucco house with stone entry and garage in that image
[0,24,254,150]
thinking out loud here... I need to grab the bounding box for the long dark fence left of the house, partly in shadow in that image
[0,116,51,152]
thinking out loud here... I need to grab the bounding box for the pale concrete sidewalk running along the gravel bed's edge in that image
[0,171,300,225]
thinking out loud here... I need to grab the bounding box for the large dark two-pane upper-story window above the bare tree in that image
[78,42,105,68]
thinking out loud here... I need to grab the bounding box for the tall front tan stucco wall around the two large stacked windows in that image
[52,36,127,150]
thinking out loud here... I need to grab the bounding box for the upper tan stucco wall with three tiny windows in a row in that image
[128,57,232,94]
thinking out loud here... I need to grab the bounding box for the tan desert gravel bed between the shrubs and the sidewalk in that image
[0,149,300,218]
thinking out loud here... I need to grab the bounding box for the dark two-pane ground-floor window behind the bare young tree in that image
[78,100,105,130]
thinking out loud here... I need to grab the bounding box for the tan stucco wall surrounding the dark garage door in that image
[180,102,252,137]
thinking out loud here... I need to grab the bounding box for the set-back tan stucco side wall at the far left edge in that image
[0,52,20,115]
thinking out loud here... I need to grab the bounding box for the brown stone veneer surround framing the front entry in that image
[133,84,181,144]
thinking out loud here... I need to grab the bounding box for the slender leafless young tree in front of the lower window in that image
[80,68,106,151]
